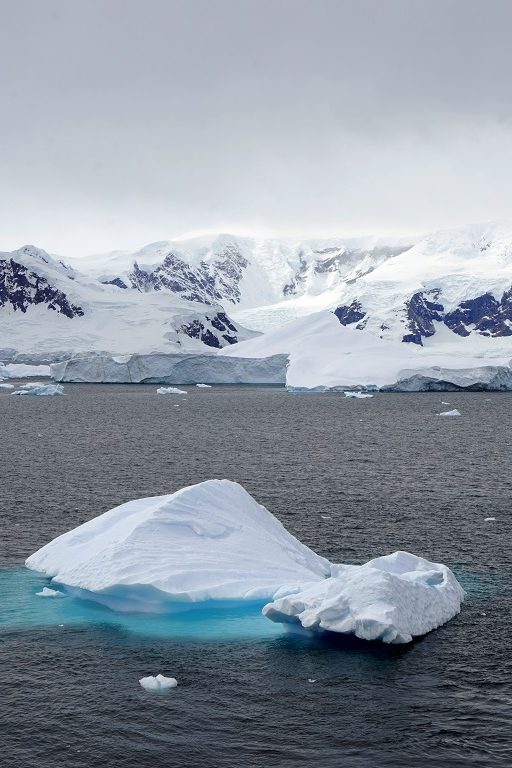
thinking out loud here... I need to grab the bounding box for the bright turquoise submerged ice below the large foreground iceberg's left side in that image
[0,567,283,641]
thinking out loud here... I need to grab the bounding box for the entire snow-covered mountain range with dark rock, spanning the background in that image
[0,222,512,356]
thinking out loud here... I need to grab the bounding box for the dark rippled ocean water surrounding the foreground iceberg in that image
[0,385,512,768]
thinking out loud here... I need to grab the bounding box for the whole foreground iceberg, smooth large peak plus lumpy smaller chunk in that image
[26,480,464,643]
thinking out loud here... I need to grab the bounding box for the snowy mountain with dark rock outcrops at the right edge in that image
[335,222,512,345]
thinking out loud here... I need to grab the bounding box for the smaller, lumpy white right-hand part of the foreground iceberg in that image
[263,552,464,643]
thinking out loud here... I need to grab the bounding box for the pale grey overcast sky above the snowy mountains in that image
[0,0,512,256]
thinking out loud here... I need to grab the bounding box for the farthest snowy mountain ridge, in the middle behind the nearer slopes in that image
[81,234,416,315]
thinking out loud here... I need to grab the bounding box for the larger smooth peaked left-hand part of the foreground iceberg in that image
[26,480,331,612]
